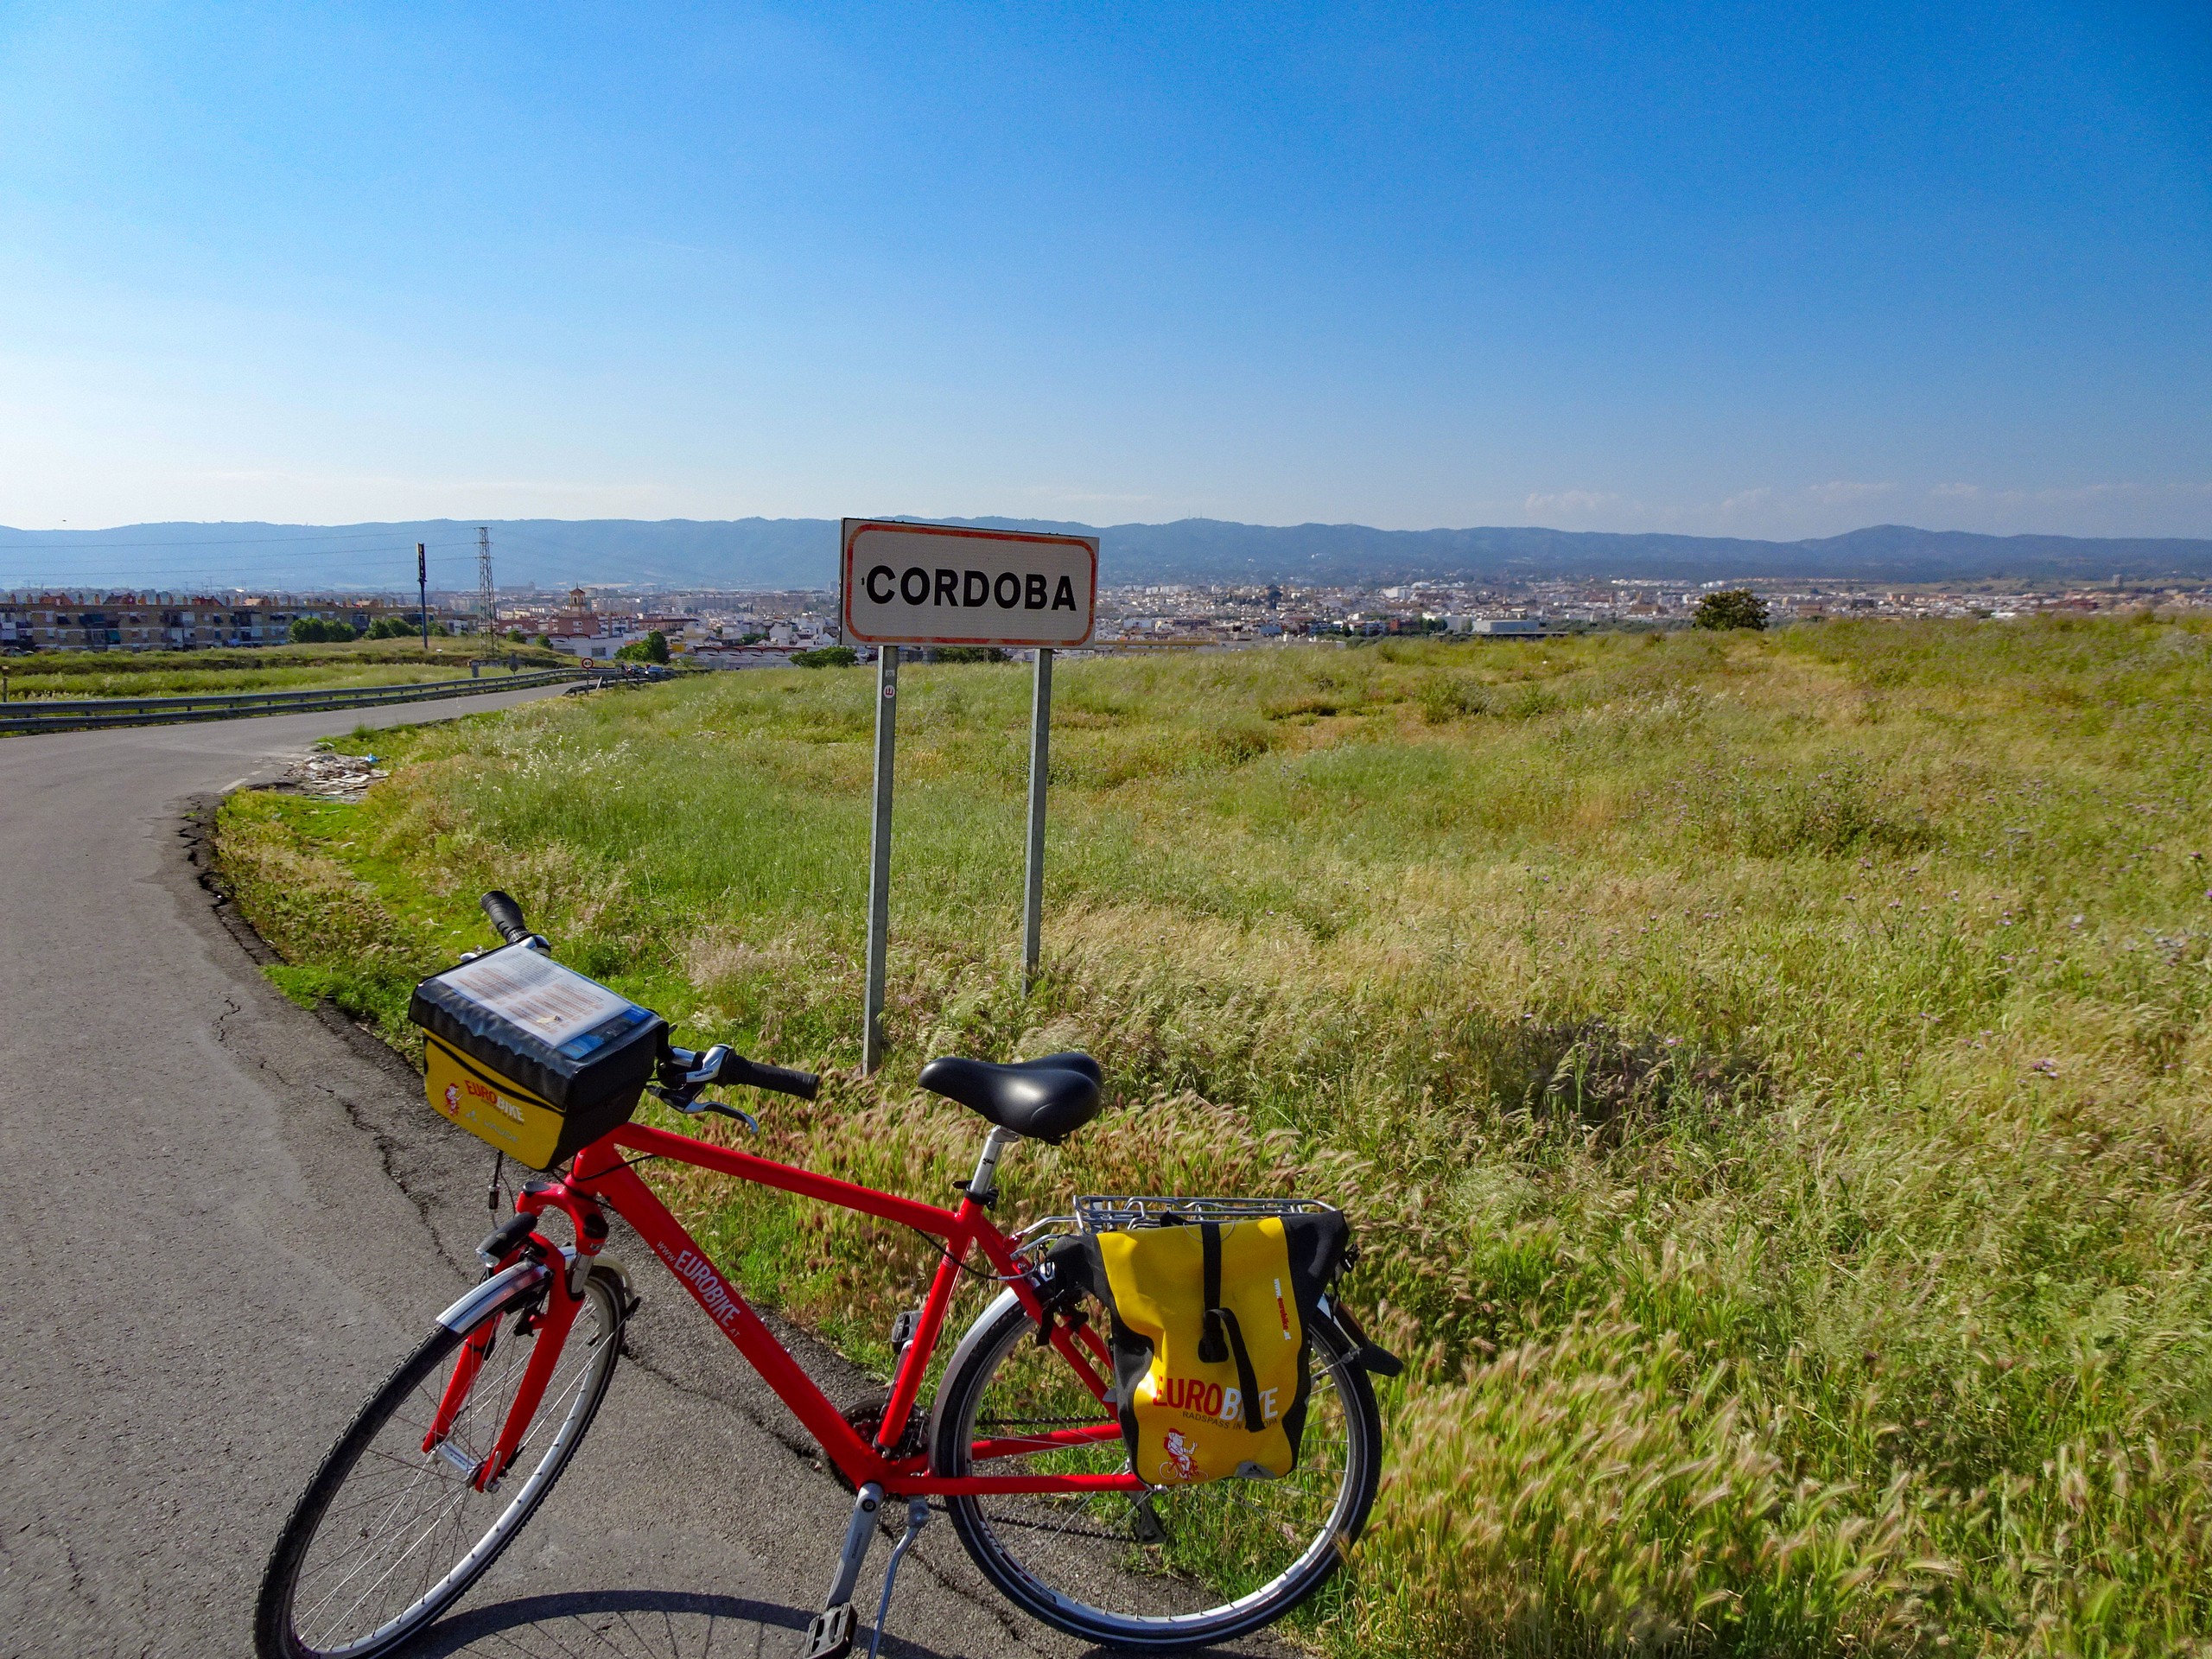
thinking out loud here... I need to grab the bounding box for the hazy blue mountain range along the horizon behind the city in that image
[0,518,2212,591]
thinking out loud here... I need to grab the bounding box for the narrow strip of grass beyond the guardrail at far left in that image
[0,637,575,699]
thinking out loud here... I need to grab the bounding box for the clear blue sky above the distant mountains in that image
[0,4,2212,536]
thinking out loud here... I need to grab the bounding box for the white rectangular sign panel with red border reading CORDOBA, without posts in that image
[841,518,1099,648]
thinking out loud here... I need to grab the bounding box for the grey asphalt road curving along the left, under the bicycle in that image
[0,692,1282,1659]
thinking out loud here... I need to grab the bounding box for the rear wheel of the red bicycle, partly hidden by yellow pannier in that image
[929,1292,1382,1652]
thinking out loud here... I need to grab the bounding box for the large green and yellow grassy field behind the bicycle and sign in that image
[221,620,2212,1655]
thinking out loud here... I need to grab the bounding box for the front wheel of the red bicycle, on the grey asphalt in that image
[254,1268,624,1659]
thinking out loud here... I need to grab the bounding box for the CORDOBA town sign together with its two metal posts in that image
[838,518,1099,1071]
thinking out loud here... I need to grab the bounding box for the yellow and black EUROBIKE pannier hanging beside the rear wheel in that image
[1090,1210,1350,1486]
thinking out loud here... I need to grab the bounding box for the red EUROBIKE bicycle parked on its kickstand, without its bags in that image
[254,902,1382,1659]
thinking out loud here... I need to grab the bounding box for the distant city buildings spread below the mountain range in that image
[0,577,2212,668]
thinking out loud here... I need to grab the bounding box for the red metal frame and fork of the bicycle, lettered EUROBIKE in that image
[442,1123,1146,1497]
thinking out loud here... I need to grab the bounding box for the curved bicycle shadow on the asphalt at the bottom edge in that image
[403,1591,963,1659]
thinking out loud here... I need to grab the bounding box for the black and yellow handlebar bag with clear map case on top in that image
[407,944,668,1170]
